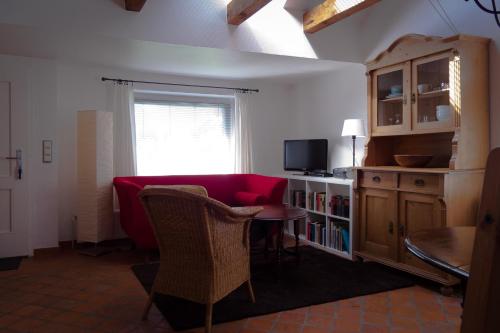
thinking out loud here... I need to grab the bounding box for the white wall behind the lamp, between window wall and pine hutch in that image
[292,64,367,169]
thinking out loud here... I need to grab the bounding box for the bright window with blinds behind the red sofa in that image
[135,100,236,176]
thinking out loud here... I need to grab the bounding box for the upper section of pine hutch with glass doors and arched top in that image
[363,35,489,170]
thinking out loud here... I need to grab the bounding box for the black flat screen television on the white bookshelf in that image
[283,139,328,174]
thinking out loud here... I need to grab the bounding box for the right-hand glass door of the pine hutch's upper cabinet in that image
[412,53,456,131]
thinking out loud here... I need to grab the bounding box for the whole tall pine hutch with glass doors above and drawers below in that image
[354,35,489,286]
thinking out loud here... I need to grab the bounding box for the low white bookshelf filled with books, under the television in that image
[279,174,354,260]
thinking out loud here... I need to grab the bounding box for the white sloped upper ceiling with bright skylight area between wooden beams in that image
[0,0,500,78]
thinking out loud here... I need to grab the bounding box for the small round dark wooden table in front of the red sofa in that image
[254,205,307,265]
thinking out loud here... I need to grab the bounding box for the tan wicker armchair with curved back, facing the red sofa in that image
[139,185,262,333]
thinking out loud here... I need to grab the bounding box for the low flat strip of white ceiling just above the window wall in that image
[0,24,346,79]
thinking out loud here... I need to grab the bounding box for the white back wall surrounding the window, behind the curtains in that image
[53,64,293,240]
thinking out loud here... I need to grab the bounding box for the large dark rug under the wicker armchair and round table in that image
[132,246,414,330]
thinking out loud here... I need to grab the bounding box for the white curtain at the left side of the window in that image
[107,82,137,177]
